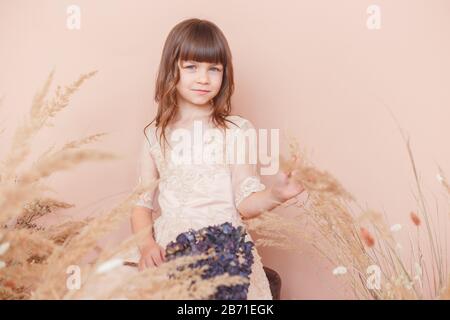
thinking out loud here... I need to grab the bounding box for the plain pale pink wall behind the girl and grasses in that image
[0,0,450,299]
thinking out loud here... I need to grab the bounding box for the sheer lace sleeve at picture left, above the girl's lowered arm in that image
[135,127,158,210]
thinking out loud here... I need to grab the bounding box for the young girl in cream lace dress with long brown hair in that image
[131,19,304,299]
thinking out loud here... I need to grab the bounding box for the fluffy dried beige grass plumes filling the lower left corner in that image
[0,71,247,299]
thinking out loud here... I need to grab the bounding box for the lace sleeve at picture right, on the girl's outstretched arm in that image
[232,118,266,208]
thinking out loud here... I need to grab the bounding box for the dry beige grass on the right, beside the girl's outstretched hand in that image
[246,134,450,299]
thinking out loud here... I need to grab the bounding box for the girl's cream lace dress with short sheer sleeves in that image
[136,116,272,300]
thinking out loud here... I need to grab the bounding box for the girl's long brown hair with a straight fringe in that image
[144,19,234,153]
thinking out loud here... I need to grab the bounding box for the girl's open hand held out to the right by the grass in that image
[272,156,305,203]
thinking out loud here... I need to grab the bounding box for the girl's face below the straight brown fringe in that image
[176,60,223,109]
